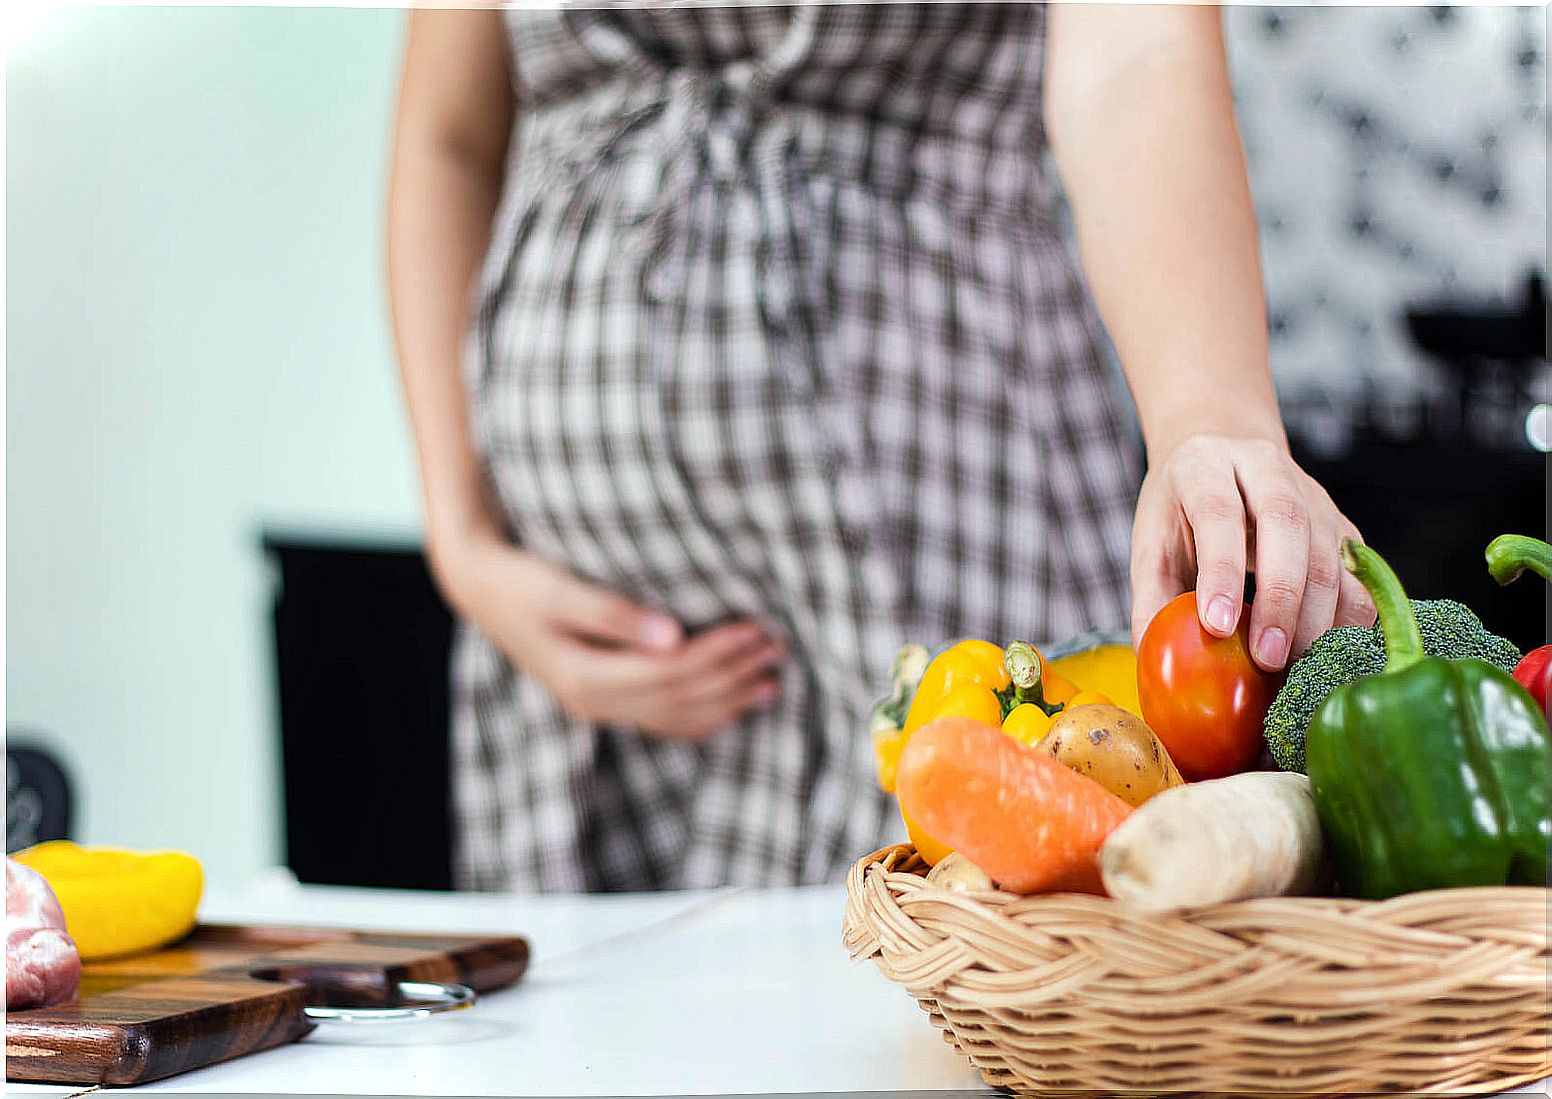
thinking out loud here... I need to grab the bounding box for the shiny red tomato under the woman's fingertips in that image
[1138,591,1284,782]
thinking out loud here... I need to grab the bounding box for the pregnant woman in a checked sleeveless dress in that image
[388,3,1372,889]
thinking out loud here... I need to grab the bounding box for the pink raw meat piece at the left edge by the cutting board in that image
[5,858,81,1011]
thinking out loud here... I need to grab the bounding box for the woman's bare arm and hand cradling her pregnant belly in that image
[388,9,784,739]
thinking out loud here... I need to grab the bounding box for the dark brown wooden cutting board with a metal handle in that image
[5,925,528,1085]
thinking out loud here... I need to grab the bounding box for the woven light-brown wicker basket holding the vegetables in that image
[846,844,1552,1096]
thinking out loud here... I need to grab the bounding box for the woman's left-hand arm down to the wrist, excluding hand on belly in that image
[386,11,512,585]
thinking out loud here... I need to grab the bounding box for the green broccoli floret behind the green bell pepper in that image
[1265,599,1521,775]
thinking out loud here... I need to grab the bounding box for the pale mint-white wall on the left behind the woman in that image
[6,8,417,879]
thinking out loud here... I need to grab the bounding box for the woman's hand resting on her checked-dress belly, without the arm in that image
[433,534,785,740]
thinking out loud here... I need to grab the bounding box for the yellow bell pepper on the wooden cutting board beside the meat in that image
[14,840,203,961]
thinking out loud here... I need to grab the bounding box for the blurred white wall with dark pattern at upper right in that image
[1226,8,1547,399]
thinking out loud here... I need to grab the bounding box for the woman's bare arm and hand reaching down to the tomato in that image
[1046,3,1374,669]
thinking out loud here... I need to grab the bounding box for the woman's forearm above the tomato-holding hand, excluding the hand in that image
[1046,5,1285,458]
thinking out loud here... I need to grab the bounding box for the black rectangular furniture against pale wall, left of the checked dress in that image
[262,531,453,889]
